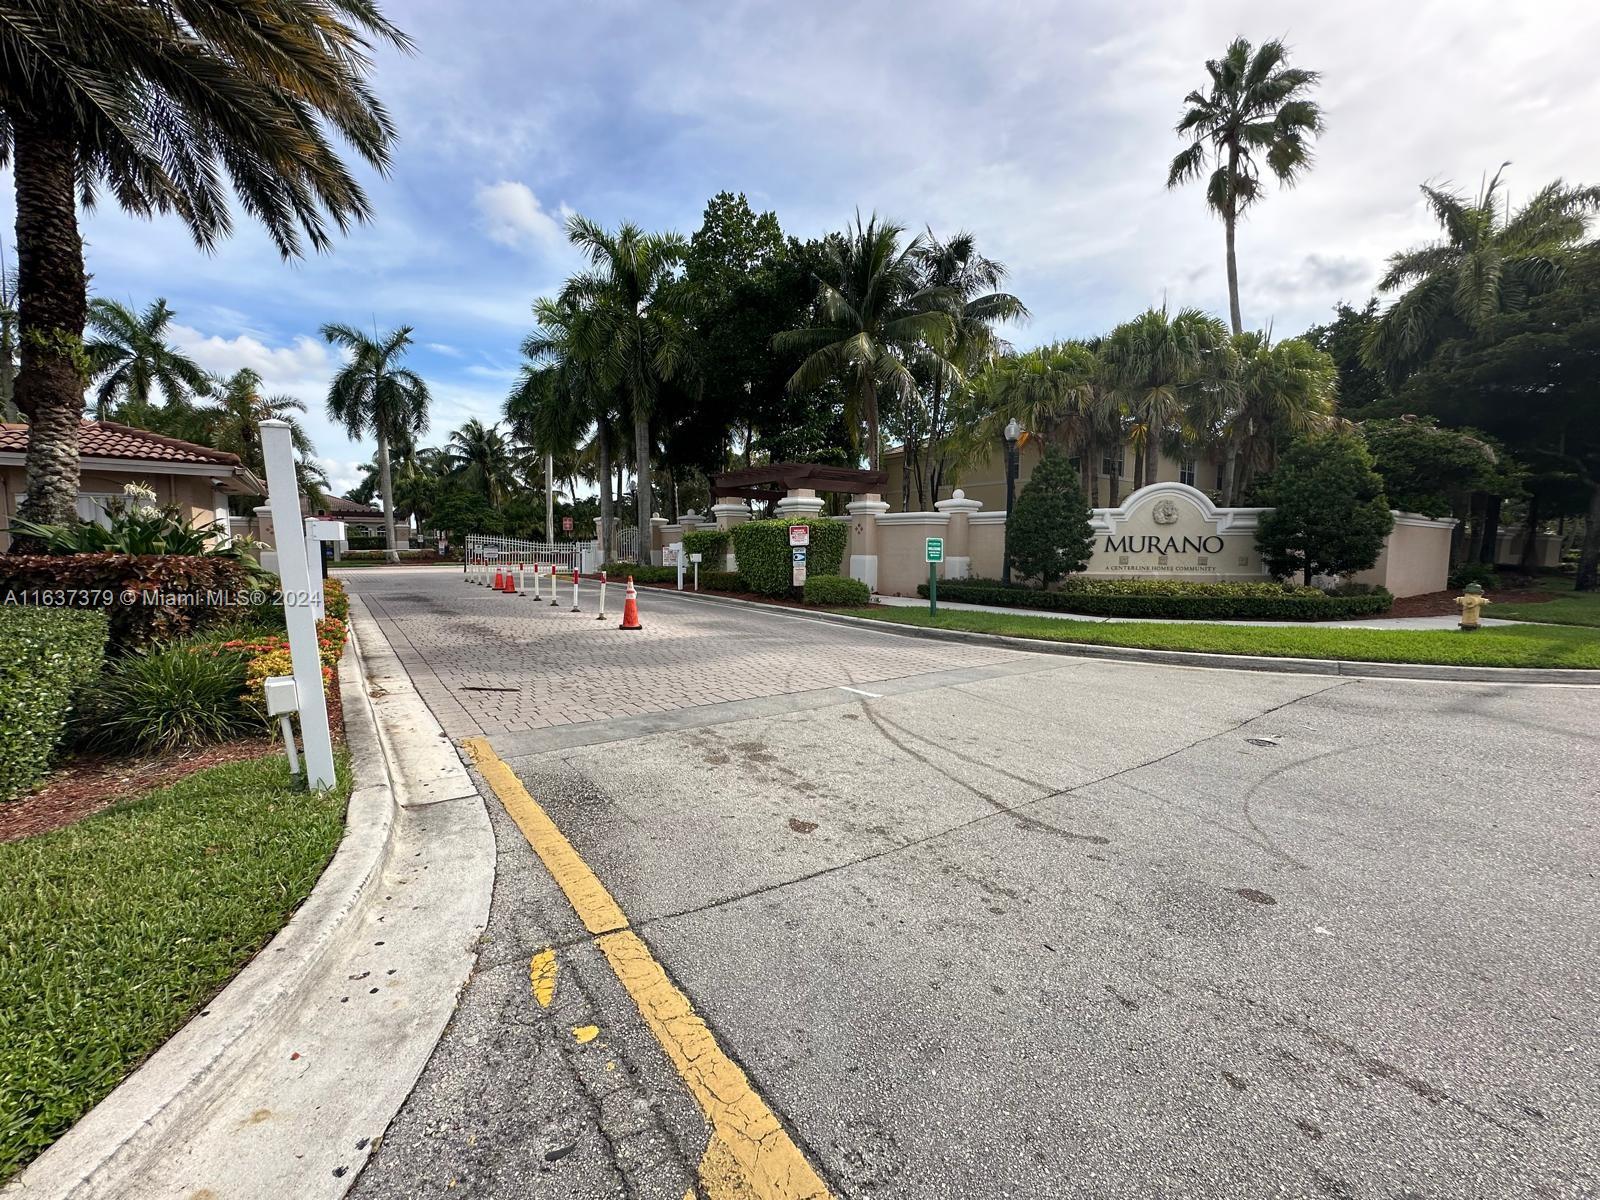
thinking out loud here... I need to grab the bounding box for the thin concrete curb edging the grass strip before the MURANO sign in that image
[633,584,1600,688]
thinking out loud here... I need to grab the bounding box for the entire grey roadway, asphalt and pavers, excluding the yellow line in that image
[350,571,1600,1200]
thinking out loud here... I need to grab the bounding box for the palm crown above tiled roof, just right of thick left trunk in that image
[83,296,211,426]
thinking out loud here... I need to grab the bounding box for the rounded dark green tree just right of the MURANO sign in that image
[1256,430,1395,584]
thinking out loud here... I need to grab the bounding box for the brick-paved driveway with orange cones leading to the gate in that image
[342,568,1019,738]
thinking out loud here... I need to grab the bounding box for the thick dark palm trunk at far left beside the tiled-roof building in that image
[11,117,88,525]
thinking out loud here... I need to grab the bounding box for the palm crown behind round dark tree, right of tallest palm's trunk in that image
[1210,333,1339,506]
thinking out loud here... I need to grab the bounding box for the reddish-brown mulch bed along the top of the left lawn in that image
[0,675,344,842]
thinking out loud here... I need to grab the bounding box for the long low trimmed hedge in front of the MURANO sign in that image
[917,581,1394,621]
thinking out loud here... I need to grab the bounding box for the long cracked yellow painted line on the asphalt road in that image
[464,738,830,1200]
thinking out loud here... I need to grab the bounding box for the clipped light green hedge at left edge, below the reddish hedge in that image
[0,606,109,800]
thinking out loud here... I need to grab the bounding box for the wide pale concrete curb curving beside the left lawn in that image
[0,597,494,1200]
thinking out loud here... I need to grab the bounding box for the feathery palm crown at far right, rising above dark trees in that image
[1362,165,1600,376]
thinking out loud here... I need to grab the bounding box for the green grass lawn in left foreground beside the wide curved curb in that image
[0,755,349,1182]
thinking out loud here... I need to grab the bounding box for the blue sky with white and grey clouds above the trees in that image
[0,0,1600,491]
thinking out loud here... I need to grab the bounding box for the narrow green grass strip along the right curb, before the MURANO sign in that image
[842,605,1600,669]
